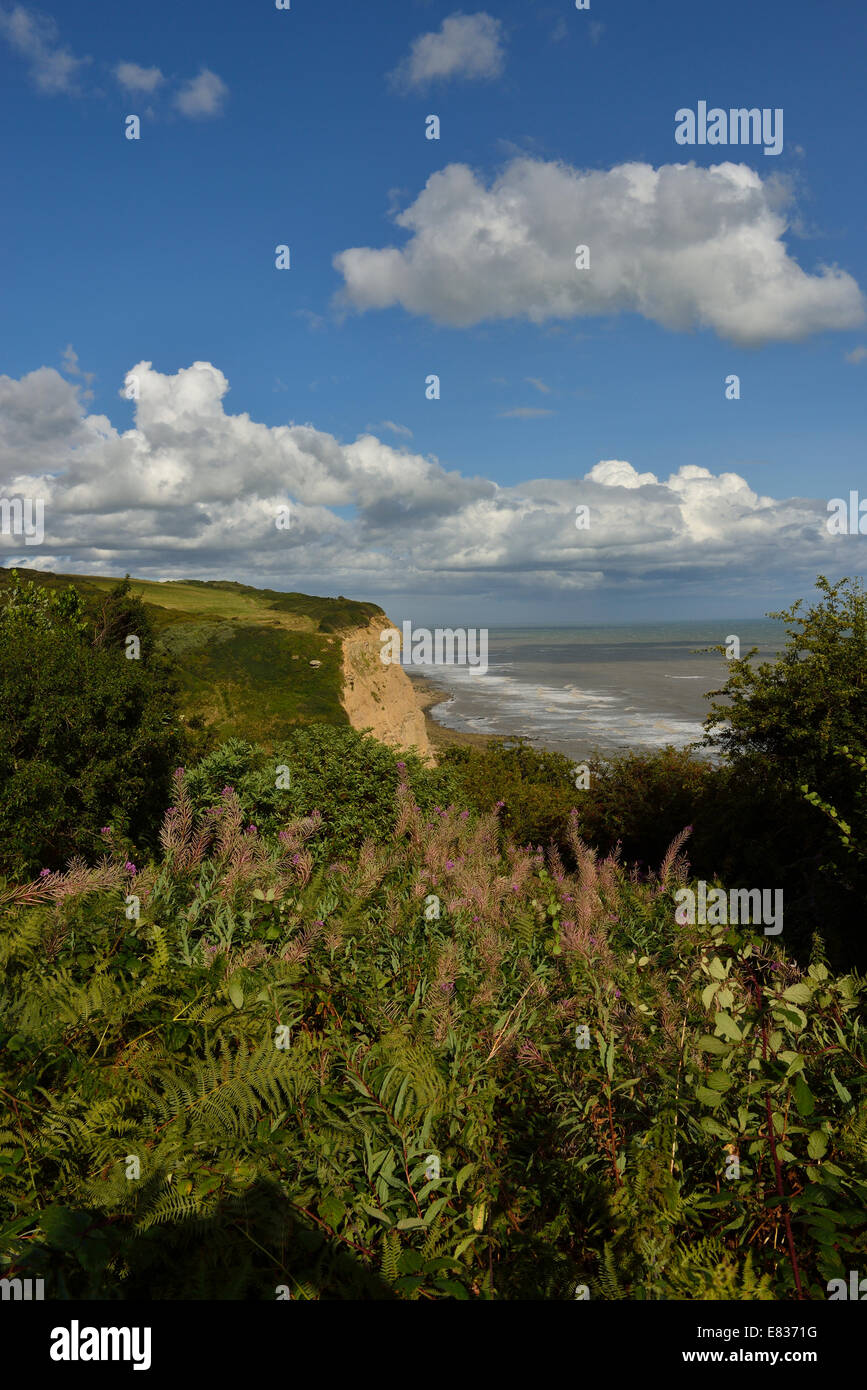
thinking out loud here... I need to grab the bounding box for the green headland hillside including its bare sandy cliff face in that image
[0,569,429,753]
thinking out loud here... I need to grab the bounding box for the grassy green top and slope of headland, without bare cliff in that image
[0,569,385,745]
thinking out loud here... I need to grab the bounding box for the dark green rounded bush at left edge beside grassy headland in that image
[0,575,182,876]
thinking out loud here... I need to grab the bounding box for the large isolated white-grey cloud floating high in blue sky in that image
[333,157,864,346]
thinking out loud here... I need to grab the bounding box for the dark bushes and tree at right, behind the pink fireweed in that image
[443,577,867,970]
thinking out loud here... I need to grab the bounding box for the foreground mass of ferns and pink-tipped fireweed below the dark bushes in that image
[0,765,867,1301]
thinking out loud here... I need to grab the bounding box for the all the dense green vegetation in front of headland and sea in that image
[0,569,867,1300]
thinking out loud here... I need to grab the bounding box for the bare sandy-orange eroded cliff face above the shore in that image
[340,617,434,759]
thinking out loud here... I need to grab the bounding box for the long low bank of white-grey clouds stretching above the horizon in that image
[0,361,864,612]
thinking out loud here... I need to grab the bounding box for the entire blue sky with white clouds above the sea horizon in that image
[0,0,867,626]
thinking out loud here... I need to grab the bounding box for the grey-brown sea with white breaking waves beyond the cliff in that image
[410,619,785,759]
